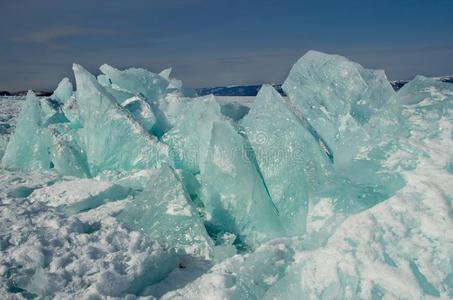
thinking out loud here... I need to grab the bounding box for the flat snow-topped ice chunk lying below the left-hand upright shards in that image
[30,179,129,214]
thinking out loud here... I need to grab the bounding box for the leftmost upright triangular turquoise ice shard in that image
[2,91,50,171]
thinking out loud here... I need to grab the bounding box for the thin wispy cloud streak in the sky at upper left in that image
[13,27,117,44]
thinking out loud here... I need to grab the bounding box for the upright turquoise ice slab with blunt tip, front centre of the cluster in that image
[201,122,285,248]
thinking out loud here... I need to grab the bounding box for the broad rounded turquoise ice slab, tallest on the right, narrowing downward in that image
[282,51,394,164]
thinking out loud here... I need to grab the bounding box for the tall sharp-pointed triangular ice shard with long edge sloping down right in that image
[73,64,168,176]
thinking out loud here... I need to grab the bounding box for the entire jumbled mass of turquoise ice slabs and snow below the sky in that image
[0,51,453,299]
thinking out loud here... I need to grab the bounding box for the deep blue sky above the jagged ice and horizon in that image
[0,0,453,90]
